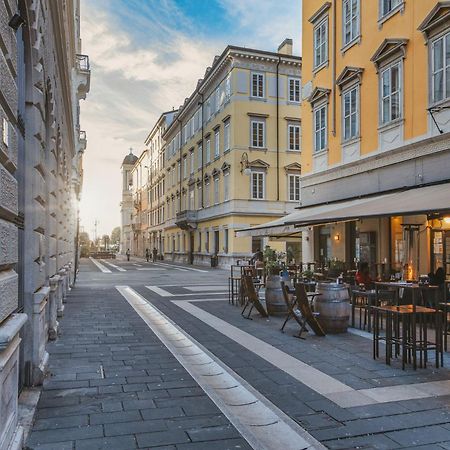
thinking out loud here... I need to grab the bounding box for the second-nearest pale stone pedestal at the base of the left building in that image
[31,286,50,386]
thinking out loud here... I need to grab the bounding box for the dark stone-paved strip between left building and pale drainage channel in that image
[27,283,250,450]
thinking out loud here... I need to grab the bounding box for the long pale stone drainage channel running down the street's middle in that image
[116,286,325,450]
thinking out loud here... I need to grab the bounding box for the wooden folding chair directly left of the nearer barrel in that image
[281,282,325,338]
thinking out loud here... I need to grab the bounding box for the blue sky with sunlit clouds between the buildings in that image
[80,0,301,238]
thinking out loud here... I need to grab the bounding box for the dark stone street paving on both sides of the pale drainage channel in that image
[27,259,450,450]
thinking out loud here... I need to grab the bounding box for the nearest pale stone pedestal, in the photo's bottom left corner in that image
[0,314,27,449]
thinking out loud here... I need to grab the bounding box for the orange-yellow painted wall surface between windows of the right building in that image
[302,0,437,173]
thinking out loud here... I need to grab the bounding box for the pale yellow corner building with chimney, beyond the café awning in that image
[161,39,301,266]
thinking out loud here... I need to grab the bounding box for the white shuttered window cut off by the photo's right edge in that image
[431,33,450,103]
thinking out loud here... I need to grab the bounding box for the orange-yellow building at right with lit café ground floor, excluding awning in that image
[301,0,450,276]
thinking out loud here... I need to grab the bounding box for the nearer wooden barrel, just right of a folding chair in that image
[314,283,351,334]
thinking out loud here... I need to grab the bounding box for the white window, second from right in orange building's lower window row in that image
[380,62,402,125]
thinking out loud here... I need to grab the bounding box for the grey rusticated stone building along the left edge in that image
[0,0,90,449]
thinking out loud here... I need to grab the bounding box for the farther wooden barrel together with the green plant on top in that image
[263,246,290,315]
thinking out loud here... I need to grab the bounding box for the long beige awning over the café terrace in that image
[236,183,450,237]
